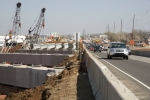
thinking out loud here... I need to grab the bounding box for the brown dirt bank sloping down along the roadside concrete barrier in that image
[5,55,95,100]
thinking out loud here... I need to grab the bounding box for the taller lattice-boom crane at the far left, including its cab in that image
[1,2,21,52]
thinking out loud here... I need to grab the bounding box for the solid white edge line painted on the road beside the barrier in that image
[94,54,150,90]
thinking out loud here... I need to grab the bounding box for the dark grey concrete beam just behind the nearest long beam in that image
[0,53,69,66]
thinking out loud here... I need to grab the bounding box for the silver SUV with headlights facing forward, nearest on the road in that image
[107,42,129,60]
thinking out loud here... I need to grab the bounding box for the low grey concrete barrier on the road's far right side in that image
[131,50,150,57]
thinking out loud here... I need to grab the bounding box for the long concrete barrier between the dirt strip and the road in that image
[85,47,138,100]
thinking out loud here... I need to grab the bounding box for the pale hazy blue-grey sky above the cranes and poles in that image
[0,0,150,35]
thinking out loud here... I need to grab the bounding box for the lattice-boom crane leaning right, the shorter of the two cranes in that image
[28,8,46,44]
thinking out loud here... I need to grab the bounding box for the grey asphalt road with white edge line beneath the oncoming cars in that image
[91,51,150,100]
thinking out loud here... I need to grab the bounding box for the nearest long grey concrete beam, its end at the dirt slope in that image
[0,64,63,88]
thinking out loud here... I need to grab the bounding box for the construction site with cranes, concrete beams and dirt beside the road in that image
[0,2,94,100]
